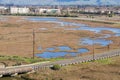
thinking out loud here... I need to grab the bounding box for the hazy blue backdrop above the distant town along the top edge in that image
[0,0,120,5]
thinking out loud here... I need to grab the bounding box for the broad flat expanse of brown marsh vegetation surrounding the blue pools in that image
[0,16,120,57]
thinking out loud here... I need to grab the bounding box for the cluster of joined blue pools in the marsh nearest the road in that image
[35,46,89,58]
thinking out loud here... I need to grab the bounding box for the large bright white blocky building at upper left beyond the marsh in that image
[10,7,30,14]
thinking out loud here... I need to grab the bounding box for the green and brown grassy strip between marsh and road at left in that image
[0,56,65,66]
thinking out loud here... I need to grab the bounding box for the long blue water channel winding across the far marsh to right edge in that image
[26,17,120,34]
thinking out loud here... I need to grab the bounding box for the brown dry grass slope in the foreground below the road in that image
[16,57,120,80]
